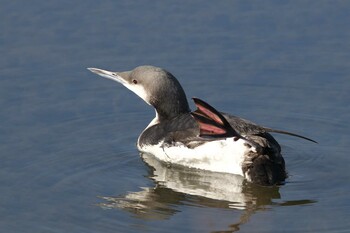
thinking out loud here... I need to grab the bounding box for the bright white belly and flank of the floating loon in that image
[139,138,254,176]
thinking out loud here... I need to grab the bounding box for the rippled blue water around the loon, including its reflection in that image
[0,0,350,232]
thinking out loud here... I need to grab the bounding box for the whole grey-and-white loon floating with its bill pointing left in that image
[88,65,316,185]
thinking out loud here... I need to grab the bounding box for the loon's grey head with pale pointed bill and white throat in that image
[88,66,190,121]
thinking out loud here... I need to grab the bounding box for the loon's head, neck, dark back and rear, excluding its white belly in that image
[89,66,315,185]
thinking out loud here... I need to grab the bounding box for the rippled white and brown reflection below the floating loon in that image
[98,154,315,231]
